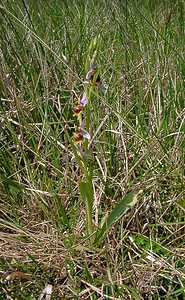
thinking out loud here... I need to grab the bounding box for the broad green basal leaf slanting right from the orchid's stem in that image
[95,190,142,242]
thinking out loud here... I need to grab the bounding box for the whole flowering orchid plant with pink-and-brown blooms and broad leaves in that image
[66,37,142,246]
